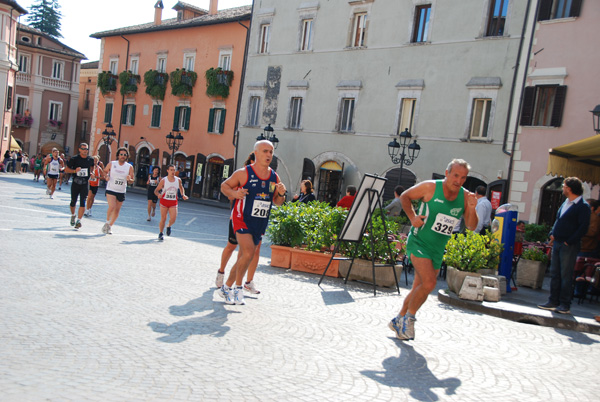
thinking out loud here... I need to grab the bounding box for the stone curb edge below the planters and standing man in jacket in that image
[438,289,600,335]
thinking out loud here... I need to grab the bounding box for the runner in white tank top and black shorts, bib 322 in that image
[102,147,134,234]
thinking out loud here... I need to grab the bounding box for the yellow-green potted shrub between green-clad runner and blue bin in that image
[444,230,504,294]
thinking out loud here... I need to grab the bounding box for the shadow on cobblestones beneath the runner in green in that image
[361,344,461,401]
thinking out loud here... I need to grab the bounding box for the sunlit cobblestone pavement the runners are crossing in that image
[0,174,600,401]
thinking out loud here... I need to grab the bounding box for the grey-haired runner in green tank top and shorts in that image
[388,159,478,340]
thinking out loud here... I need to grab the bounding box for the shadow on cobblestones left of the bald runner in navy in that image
[148,288,239,343]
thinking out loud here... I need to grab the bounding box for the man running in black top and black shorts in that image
[65,142,95,229]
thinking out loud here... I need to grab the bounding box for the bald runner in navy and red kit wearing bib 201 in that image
[219,140,286,304]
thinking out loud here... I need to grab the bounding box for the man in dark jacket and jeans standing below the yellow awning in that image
[538,177,590,314]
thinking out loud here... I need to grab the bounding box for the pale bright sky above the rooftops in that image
[16,0,252,62]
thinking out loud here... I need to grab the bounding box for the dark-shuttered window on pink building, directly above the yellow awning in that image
[521,85,567,127]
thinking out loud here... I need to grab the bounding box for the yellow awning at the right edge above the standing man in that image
[546,135,600,184]
